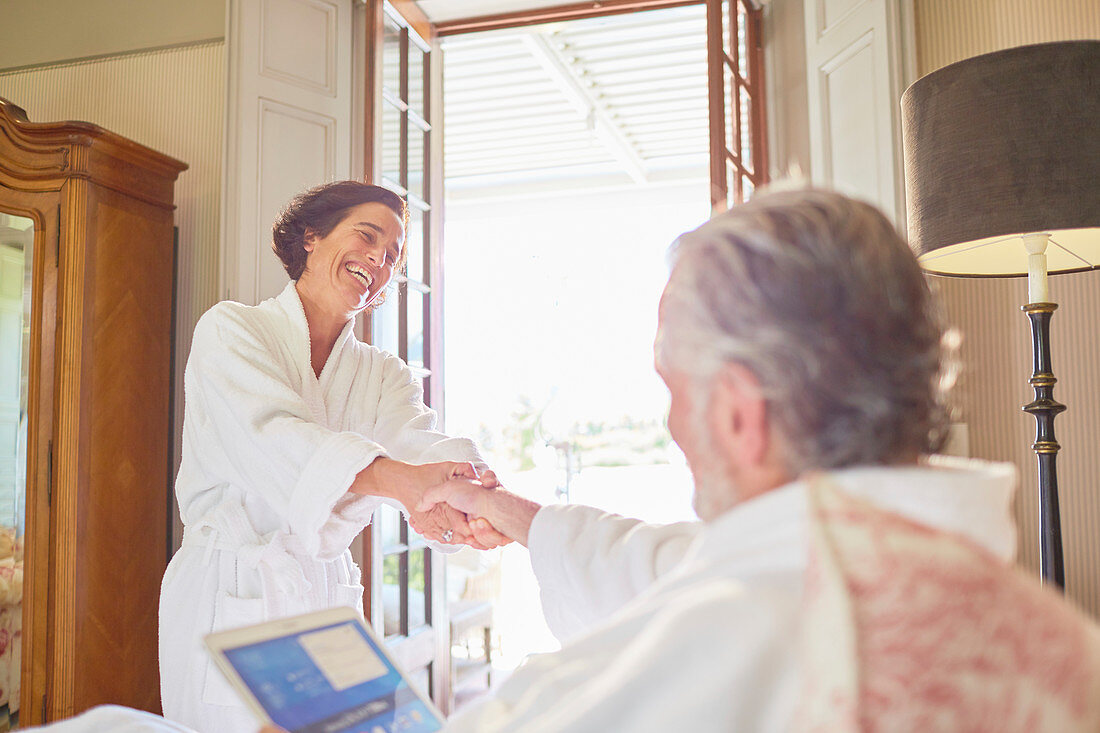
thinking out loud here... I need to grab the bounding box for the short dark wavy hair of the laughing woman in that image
[272,180,409,281]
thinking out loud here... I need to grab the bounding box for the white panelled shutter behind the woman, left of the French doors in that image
[222,0,352,304]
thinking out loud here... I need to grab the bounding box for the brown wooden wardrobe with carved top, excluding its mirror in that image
[0,99,187,726]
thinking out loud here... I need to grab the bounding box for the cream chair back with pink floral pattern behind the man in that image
[798,477,1100,733]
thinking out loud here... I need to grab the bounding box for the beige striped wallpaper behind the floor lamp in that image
[915,0,1100,616]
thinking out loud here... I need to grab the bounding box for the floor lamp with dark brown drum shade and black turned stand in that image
[902,41,1100,588]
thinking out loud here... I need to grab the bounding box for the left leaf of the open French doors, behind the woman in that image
[363,0,450,708]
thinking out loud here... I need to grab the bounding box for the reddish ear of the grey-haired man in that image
[710,363,771,467]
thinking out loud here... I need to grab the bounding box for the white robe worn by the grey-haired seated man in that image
[447,453,1015,733]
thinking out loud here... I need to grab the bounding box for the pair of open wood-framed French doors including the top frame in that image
[362,0,768,712]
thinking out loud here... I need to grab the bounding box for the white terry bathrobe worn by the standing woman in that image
[161,283,482,733]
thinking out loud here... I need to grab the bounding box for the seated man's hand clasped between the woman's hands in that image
[416,471,542,547]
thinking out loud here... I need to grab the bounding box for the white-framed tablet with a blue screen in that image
[206,608,444,733]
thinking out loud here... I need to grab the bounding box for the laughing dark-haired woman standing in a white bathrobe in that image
[161,180,506,733]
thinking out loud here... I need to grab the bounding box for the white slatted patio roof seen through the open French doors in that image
[443,0,708,196]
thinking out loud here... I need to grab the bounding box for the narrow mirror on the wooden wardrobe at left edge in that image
[0,214,34,731]
